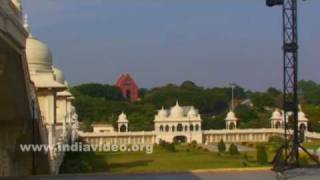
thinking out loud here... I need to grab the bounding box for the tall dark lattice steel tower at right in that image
[266,0,319,170]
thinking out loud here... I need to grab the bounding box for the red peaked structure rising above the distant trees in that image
[116,74,140,102]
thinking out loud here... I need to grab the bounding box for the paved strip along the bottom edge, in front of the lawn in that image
[15,168,320,180]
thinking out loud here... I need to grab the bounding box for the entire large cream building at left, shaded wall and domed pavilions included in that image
[0,0,78,176]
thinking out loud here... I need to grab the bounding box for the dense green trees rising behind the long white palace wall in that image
[72,81,320,132]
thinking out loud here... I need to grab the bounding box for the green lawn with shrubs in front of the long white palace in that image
[61,145,270,173]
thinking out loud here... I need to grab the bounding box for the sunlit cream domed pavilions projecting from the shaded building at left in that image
[25,18,78,174]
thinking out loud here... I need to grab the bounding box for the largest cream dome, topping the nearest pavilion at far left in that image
[26,37,52,72]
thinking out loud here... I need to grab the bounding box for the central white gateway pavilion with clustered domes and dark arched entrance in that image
[154,102,202,143]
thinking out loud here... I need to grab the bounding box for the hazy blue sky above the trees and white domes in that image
[23,0,320,90]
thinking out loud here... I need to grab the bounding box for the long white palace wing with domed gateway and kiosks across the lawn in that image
[79,102,320,144]
